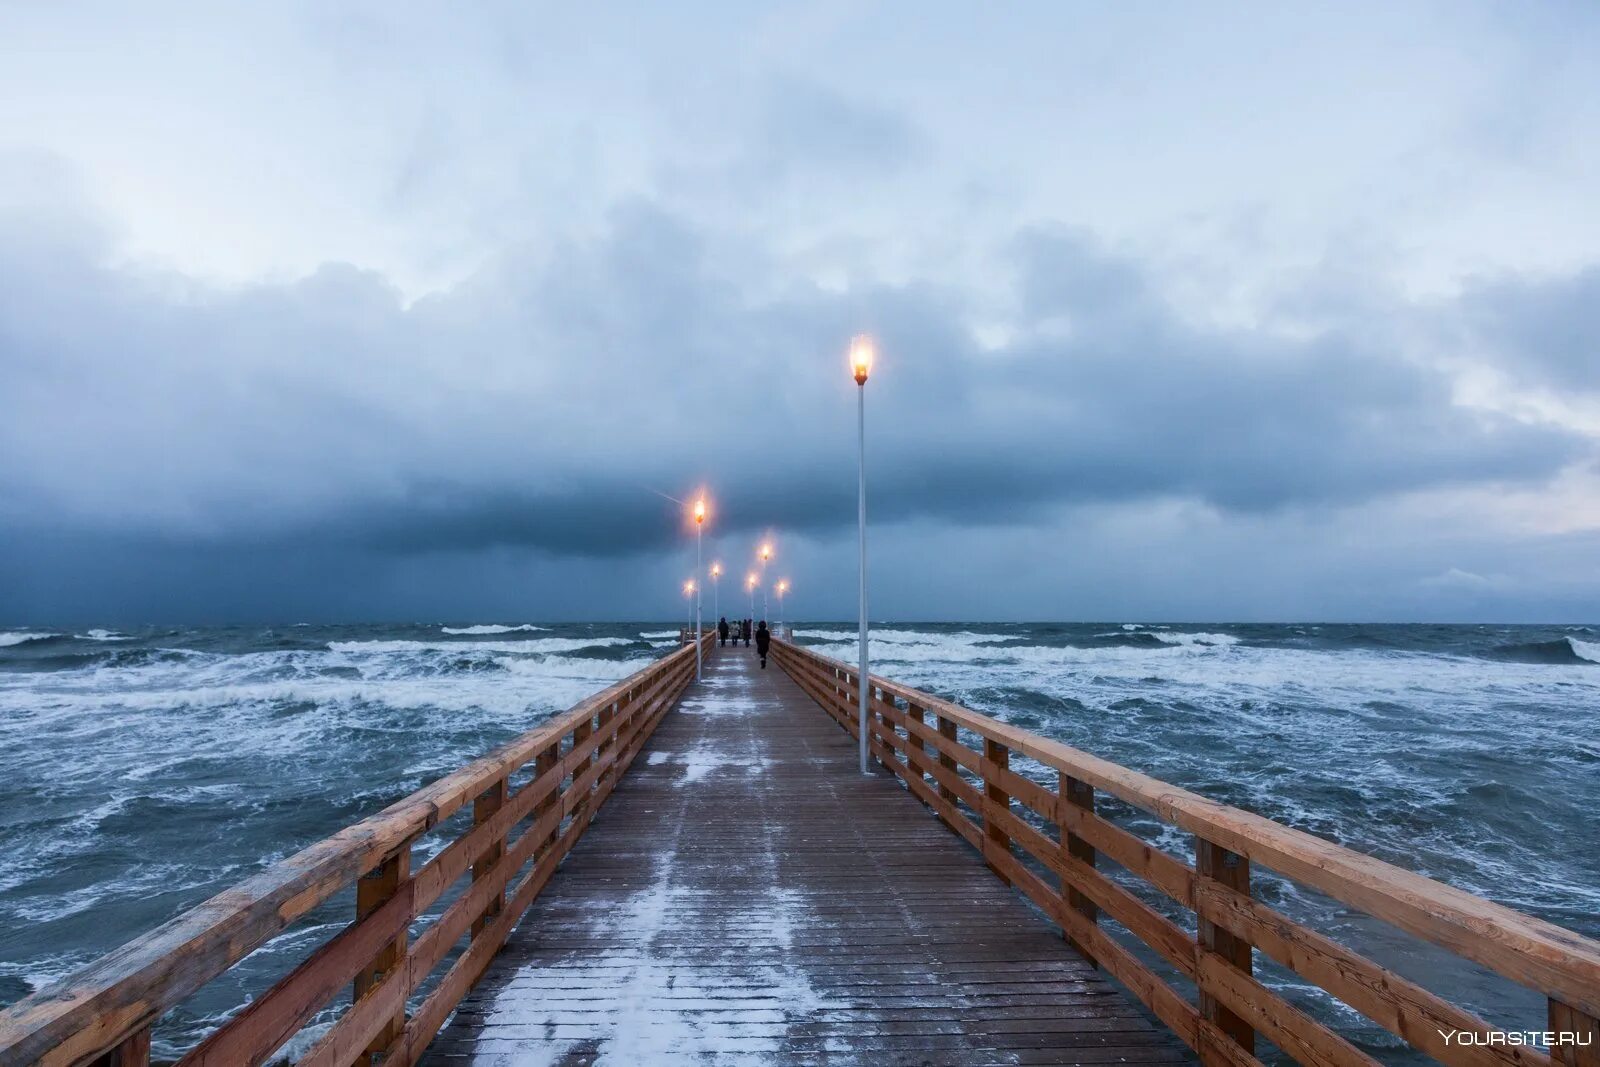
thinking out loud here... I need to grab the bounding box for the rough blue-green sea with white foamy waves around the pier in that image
[0,621,1600,1062]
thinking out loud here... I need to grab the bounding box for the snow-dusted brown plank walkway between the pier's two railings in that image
[424,648,1189,1065]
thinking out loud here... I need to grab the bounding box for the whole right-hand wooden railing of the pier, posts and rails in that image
[773,640,1600,1067]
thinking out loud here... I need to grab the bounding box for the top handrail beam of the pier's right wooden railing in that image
[774,640,1600,1062]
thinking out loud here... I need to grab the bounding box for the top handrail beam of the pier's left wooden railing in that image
[0,645,707,1064]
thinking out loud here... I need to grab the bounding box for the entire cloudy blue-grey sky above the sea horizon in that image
[0,0,1600,624]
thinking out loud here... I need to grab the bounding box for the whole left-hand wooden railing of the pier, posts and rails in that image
[0,635,715,1067]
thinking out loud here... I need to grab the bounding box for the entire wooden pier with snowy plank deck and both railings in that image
[0,633,1600,1067]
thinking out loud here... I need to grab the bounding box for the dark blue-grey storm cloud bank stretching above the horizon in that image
[0,203,1592,585]
